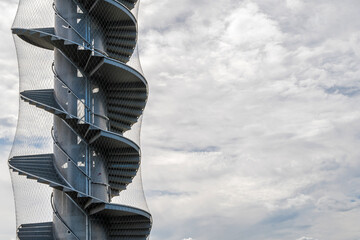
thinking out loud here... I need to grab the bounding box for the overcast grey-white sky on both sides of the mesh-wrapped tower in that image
[0,0,360,240]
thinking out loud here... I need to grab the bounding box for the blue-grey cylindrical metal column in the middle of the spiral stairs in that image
[54,0,109,240]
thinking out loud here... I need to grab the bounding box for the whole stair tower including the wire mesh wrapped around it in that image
[9,0,152,240]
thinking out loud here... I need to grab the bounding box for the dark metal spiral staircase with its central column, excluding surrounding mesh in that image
[8,0,152,240]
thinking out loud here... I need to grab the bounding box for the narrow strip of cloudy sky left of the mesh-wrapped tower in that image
[0,1,18,240]
